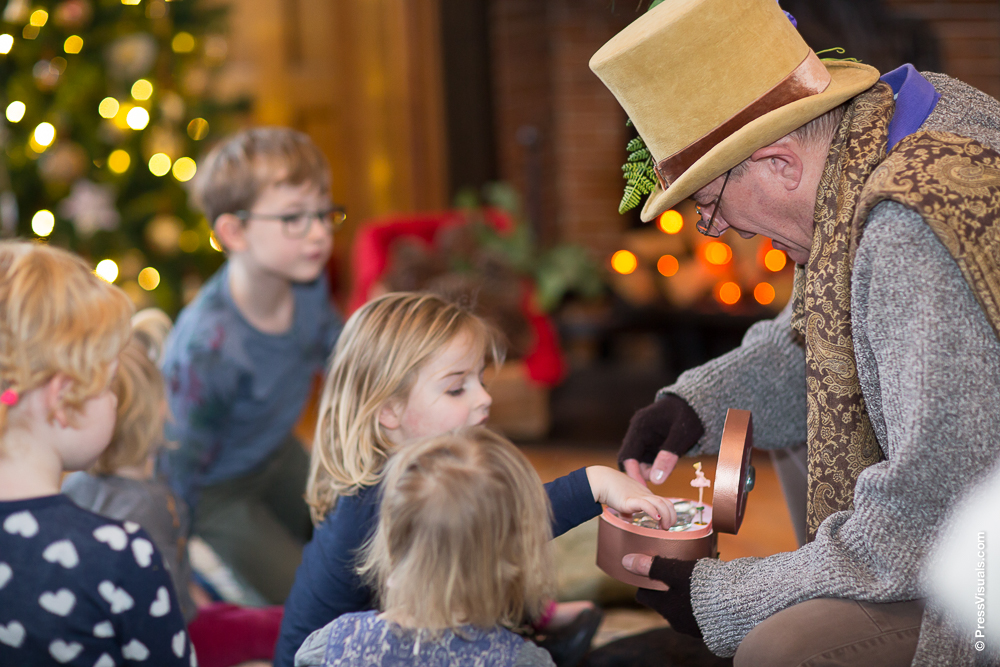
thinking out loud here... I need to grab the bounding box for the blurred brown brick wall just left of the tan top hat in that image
[490,0,635,257]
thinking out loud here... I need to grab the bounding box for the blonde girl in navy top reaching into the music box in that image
[275,292,675,667]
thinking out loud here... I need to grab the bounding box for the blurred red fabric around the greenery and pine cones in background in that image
[347,209,566,387]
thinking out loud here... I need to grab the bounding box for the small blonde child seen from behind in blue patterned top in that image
[296,427,554,667]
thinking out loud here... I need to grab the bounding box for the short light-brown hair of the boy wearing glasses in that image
[194,127,330,225]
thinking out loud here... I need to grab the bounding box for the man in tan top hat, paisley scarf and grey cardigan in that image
[590,0,1000,667]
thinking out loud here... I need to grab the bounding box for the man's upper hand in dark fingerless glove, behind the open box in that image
[618,394,705,484]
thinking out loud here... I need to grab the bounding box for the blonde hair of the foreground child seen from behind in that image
[359,426,554,630]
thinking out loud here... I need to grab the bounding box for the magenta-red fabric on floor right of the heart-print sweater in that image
[188,602,285,667]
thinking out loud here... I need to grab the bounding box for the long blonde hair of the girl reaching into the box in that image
[306,292,503,523]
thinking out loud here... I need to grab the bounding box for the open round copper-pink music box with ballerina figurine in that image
[597,409,754,591]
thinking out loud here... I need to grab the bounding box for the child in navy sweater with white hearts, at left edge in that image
[0,242,193,667]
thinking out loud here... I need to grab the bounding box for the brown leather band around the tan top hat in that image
[654,51,831,190]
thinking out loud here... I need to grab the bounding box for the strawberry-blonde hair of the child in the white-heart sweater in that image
[0,241,132,433]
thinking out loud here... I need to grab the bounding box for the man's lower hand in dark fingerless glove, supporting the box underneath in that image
[622,554,701,639]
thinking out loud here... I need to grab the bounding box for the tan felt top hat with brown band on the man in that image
[590,0,879,221]
